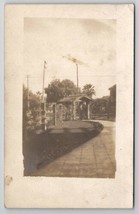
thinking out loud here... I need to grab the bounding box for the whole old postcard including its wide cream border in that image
[4,4,134,208]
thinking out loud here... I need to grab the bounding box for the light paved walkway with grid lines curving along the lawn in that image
[33,121,116,178]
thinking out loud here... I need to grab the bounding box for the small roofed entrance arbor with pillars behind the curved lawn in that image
[57,95,92,120]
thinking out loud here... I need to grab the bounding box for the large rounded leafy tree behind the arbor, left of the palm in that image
[45,79,77,103]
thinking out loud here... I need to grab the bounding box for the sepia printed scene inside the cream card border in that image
[22,17,117,178]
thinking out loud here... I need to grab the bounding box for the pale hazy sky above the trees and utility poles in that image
[24,18,116,97]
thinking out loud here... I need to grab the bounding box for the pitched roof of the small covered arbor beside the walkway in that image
[58,95,92,103]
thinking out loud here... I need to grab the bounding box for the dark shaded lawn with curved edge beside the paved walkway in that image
[23,121,103,176]
